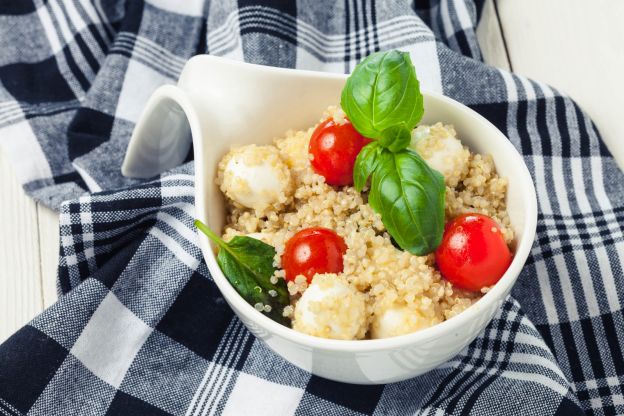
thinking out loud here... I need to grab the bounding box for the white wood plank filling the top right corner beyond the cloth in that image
[496,0,624,168]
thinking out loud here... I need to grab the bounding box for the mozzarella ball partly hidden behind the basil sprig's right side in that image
[410,123,470,187]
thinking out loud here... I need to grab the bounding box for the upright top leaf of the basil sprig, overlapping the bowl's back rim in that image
[340,50,424,148]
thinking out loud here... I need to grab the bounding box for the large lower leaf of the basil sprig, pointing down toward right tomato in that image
[368,149,446,256]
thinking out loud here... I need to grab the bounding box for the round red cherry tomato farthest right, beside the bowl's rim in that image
[435,214,511,291]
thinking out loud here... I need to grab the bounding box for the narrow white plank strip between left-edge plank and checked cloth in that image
[37,204,59,308]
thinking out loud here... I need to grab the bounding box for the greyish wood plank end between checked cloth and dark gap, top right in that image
[477,0,510,71]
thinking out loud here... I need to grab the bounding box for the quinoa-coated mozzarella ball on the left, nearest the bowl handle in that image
[217,144,294,214]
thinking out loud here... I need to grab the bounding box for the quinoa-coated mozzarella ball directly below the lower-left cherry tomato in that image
[293,274,367,340]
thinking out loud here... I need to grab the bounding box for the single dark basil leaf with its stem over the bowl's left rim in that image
[195,220,290,326]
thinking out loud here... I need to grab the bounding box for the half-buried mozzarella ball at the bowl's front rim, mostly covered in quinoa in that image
[371,304,439,338]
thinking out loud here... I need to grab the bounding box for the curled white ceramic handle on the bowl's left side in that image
[121,85,195,179]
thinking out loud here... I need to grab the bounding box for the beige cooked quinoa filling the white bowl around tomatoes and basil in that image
[218,107,513,339]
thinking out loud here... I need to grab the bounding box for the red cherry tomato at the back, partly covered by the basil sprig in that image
[308,118,370,186]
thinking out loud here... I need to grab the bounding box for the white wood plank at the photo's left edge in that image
[0,149,43,342]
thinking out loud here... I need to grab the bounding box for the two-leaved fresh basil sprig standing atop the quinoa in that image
[340,51,446,255]
